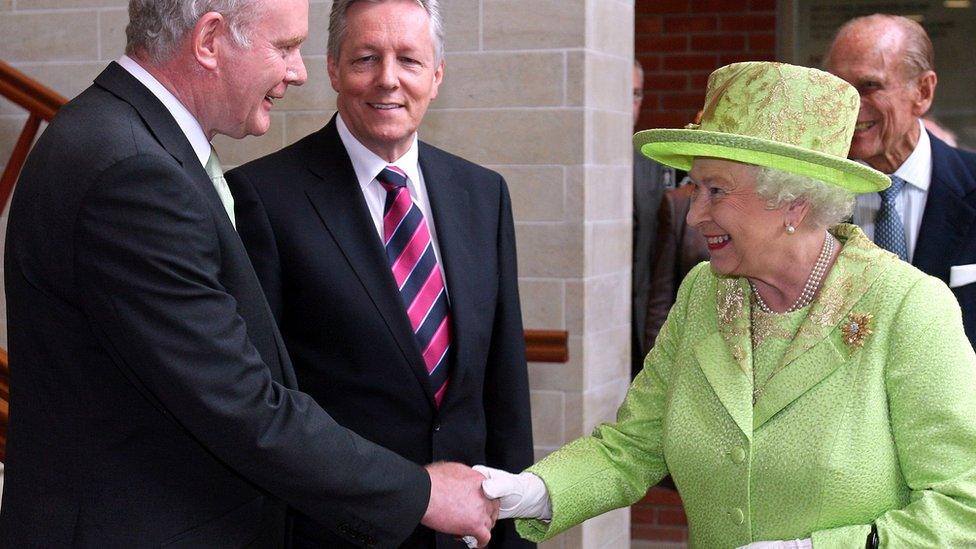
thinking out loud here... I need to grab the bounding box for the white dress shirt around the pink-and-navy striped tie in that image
[336,114,450,299]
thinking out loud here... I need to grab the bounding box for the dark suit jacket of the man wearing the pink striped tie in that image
[227,118,533,547]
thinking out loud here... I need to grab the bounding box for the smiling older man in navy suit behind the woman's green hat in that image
[825,14,976,342]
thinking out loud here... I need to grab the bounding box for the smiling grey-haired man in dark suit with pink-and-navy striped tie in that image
[228,0,533,548]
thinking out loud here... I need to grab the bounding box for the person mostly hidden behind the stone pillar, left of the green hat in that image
[630,59,674,376]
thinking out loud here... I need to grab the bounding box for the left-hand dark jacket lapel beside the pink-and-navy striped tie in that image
[302,118,434,406]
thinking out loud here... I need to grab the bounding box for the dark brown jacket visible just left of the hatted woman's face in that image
[644,185,709,350]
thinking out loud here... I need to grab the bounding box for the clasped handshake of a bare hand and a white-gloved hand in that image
[420,462,552,547]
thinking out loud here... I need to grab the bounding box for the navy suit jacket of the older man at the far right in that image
[912,133,976,345]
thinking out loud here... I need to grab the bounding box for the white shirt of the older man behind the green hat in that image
[854,120,932,263]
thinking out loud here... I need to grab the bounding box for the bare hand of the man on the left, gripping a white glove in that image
[420,462,498,547]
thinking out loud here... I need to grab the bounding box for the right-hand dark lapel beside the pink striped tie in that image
[420,143,481,394]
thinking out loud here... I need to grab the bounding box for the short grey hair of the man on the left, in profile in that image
[125,0,263,63]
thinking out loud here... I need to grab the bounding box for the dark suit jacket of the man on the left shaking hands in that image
[0,63,430,548]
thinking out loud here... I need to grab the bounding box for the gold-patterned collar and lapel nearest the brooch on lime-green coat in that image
[753,225,885,429]
